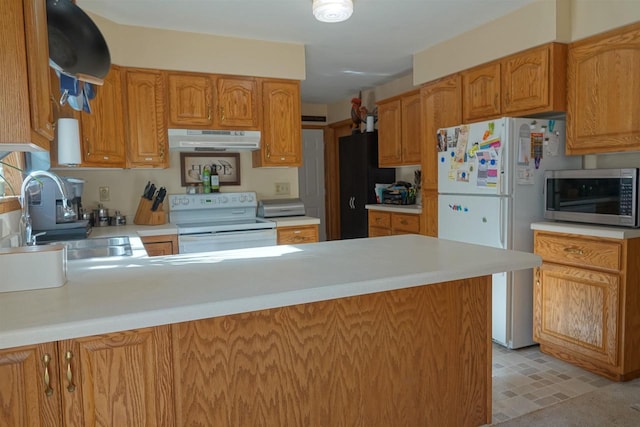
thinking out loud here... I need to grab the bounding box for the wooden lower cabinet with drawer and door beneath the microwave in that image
[533,231,640,381]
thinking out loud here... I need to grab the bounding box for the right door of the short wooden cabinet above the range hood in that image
[215,76,261,129]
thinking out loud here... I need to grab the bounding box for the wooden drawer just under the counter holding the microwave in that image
[534,233,622,271]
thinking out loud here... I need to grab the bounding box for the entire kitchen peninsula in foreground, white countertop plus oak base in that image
[0,235,540,426]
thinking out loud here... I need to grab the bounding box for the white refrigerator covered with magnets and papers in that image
[437,117,582,348]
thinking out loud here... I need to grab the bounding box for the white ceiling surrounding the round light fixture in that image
[77,0,535,104]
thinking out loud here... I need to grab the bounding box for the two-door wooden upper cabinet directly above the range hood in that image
[167,72,261,130]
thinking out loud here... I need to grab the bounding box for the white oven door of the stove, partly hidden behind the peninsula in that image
[178,228,277,254]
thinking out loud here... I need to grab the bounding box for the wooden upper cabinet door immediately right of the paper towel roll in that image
[81,65,126,168]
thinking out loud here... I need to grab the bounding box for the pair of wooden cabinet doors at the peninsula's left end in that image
[0,326,175,427]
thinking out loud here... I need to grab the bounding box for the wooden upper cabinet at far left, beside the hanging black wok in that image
[0,0,54,151]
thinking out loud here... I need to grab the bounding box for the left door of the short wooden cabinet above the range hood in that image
[167,72,213,128]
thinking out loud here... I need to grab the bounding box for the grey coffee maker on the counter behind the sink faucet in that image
[28,177,91,242]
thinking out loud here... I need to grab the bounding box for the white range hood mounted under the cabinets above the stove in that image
[169,129,260,152]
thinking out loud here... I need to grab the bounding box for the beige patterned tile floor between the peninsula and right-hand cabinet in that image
[492,344,613,423]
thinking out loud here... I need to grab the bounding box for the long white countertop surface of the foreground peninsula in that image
[0,235,541,349]
